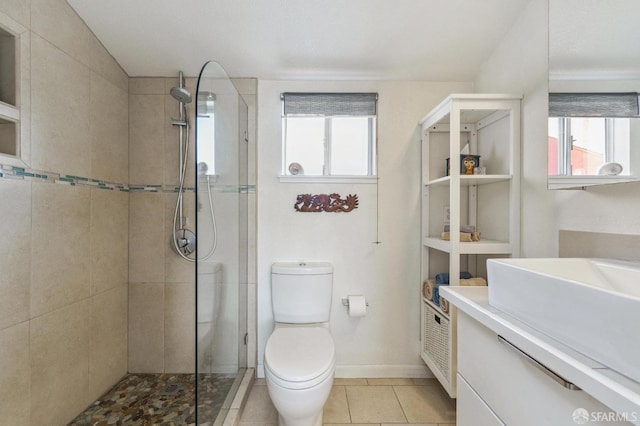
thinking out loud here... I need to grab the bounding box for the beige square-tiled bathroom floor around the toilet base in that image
[239,378,456,426]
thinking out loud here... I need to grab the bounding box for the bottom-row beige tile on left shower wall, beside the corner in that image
[89,284,128,399]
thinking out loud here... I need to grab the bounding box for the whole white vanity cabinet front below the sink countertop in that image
[457,310,632,426]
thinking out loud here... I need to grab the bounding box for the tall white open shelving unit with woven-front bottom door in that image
[420,94,521,398]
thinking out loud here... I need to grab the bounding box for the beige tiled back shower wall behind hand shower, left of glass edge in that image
[129,77,196,373]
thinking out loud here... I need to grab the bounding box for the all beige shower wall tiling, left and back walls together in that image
[0,0,256,426]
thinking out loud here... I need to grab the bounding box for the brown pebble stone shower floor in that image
[68,374,235,426]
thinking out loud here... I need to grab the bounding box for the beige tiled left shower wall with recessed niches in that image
[0,0,129,426]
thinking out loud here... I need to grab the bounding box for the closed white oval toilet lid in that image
[264,327,335,382]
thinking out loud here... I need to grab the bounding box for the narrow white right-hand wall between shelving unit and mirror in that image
[476,0,558,257]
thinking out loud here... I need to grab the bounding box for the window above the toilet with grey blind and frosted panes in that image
[281,93,378,177]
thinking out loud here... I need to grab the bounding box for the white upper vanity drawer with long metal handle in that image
[458,311,631,426]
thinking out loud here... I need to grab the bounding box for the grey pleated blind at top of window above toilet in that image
[280,92,378,116]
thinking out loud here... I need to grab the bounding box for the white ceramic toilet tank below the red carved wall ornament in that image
[271,262,333,324]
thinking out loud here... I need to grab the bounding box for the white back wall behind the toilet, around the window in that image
[257,81,473,377]
